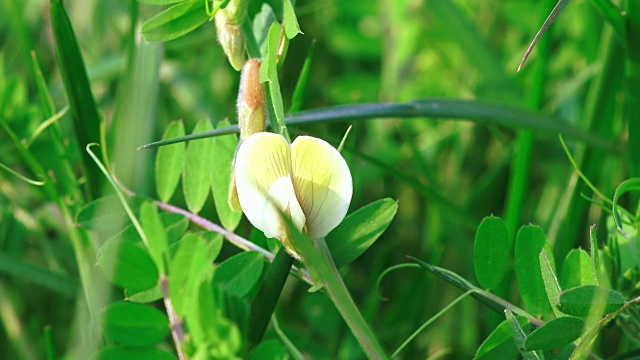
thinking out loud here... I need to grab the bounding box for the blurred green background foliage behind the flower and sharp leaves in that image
[0,0,640,359]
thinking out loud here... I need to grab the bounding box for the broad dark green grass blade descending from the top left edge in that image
[50,0,102,199]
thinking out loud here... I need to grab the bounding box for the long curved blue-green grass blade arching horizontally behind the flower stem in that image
[138,99,616,151]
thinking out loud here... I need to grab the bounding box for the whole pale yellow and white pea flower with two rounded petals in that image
[235,132,353,258]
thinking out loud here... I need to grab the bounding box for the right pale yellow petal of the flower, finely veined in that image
[291,136,353,239]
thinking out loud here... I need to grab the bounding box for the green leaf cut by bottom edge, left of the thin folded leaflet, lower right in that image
[475,316,531,360]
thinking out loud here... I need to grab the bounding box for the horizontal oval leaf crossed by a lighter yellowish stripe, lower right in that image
[558,285,625,316]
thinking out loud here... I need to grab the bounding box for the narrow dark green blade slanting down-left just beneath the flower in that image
[247,247,293,350]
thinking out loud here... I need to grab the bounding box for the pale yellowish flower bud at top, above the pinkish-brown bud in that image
[215,7,246,71]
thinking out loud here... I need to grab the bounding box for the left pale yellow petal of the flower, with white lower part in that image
[235,132,305,240]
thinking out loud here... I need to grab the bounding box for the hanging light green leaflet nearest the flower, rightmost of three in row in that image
[211,120,242,231]
